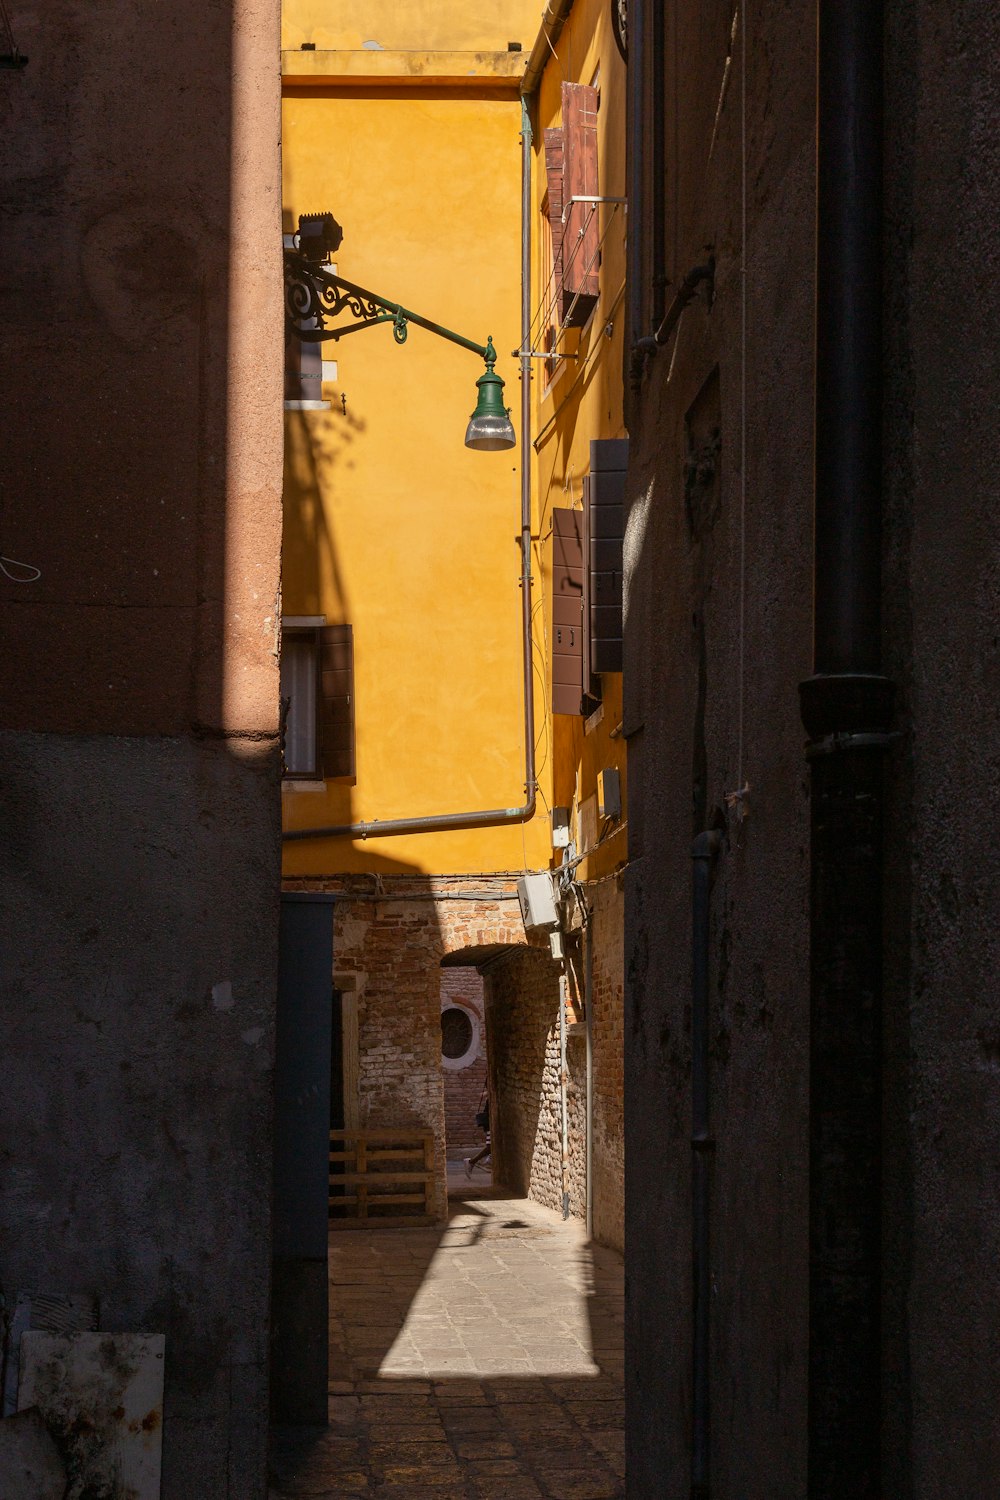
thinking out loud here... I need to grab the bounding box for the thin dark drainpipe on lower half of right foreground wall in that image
[691,830,723,1500]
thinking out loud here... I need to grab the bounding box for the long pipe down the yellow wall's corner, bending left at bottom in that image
[282,98,539,843]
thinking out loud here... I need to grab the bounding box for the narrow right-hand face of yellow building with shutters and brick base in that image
[529,0,627,1248]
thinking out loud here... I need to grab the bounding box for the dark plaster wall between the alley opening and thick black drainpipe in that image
[625,3,816,1500]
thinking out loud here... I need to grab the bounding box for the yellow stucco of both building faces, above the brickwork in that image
[283,0,625,878]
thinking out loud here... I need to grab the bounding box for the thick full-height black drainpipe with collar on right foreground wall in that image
[801,0,894,1500]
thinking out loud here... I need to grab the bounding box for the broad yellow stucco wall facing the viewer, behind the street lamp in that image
[283,76,550,876]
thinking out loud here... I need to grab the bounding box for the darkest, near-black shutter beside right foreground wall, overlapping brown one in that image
[583,438,628,683]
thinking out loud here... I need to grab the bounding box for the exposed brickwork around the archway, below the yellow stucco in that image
[281,875,624,1230]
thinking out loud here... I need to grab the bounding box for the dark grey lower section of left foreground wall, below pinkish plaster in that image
[0,734,277,1500]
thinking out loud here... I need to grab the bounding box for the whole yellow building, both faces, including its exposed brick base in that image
[282,0,624,1242]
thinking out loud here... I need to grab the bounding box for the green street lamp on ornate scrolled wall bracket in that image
[285,213,514,453]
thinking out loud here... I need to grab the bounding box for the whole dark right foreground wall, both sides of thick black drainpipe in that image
[625,0,1000,1500]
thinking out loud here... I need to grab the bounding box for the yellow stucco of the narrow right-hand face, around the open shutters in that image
[532,0,627,879]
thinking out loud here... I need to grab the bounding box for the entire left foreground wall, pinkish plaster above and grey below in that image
[0,0,282,1500]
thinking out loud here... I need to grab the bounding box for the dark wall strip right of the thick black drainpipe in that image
[885,0,1000,1500]
